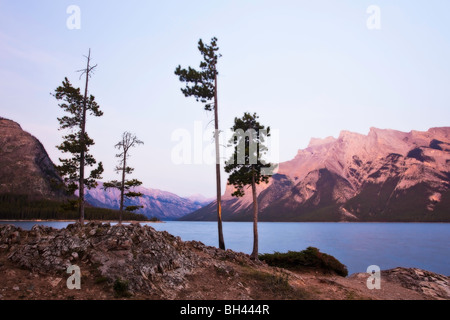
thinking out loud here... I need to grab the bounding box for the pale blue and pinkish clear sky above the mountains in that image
[0,0,450,197]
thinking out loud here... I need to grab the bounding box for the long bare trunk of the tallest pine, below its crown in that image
[214,73,225,250]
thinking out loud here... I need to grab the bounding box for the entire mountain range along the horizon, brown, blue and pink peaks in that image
[0,117,450,221]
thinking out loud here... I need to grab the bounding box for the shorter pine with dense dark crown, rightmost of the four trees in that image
[225,113,272,260]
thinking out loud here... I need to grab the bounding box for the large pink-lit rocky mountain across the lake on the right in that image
[182,127,450,221]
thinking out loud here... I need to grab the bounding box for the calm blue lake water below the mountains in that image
[0,221,450,275]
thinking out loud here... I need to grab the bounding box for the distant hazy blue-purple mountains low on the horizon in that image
[85,182,206,220]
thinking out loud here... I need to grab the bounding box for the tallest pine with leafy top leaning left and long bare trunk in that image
[175,37,225,250]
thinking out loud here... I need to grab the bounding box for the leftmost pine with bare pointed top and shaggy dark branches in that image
[52,50,103,224]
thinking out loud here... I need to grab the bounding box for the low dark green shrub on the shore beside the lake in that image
[259,247,348,277]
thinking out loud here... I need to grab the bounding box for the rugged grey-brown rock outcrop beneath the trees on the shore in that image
[0,222,276,299]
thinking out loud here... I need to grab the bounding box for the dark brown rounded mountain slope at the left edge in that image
[0,117,64,199]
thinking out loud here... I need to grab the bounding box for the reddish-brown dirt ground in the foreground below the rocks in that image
[0,254,438,300]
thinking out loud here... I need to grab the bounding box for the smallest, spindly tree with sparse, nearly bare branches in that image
[103,132,144,224]
